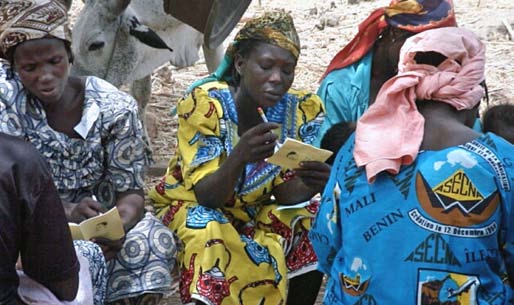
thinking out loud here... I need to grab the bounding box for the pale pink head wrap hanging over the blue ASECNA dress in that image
[353,27,485,182]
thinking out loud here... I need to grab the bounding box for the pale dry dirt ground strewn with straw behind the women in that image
[67,0,508,304]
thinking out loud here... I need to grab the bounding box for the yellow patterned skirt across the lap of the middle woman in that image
[160,197,317,303]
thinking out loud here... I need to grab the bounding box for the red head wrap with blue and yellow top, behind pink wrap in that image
[321,0,457,79]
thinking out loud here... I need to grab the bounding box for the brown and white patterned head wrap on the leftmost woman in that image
[0,0,71,58]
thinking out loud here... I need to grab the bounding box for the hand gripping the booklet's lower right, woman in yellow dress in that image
[294,161,331,193]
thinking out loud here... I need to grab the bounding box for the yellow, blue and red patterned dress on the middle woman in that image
[150,81,324,305]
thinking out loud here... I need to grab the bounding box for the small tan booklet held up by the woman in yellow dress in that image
[266,138,332,169]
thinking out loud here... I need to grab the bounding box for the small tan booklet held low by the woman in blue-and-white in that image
[68,207,125,240]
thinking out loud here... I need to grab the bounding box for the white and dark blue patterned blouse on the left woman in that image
[0,60,151,208]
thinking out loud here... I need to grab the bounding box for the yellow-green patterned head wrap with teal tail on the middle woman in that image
[187,10,300,92]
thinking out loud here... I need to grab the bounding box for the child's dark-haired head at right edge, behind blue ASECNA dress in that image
[482,104,514,144]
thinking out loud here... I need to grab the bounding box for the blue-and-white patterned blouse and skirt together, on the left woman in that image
[0,59,176,302]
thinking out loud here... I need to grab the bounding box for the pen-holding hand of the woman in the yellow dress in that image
[234,123,279,164]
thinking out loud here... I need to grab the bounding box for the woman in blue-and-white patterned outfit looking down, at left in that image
[0,0,175,302]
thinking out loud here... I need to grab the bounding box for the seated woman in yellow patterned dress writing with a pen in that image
[150,11,330,305]
